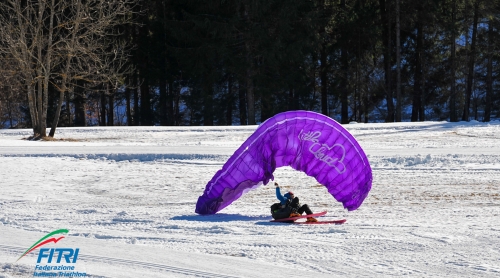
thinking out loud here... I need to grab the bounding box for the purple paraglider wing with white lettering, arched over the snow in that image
[196,111,372,214]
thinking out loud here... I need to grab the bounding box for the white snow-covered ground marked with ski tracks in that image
[0,122,500,277]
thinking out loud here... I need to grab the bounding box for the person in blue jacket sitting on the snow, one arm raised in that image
[271,182,318,222]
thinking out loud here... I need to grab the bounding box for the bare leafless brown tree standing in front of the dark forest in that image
[0,0,134,138]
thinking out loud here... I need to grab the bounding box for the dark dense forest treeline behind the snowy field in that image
[0,0,500,133]
